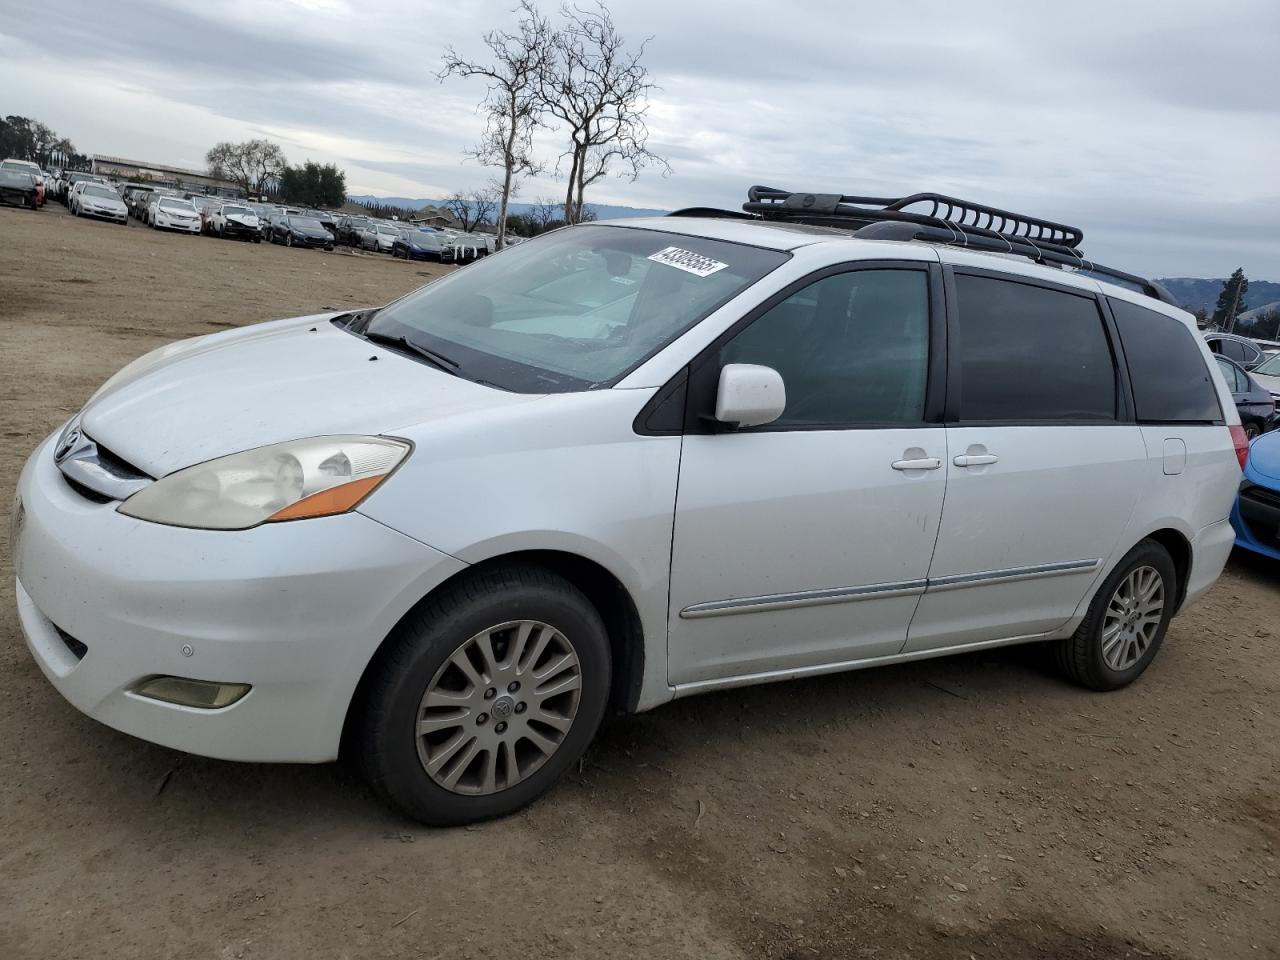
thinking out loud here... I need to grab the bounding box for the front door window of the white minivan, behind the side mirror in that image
[719,270,929,430]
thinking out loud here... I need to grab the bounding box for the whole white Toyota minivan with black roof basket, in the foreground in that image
[13,188,1247,824]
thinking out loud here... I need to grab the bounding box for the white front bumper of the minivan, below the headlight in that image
[14,436,465,763]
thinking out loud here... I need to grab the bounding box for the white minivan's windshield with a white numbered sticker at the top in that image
[369,227,788,393]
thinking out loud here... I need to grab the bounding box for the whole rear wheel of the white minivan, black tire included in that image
[1053,540,1178,690]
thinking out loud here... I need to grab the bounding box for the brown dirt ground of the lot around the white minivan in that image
[0,206,1280,960]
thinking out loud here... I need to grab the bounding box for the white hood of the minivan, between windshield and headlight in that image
[81,314,538,477]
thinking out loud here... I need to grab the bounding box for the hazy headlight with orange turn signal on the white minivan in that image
[116,436,411,530]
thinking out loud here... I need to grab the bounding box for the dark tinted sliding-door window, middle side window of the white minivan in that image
[956,274,1116,421]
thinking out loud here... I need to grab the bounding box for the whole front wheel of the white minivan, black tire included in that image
[355,566,612,827]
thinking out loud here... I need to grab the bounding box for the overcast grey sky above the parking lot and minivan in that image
[0,0,1280,280]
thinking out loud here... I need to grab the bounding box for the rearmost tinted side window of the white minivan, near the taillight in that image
[1107,298,1222,422]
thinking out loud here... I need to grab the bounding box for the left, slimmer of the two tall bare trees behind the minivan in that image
[440,0,553,250]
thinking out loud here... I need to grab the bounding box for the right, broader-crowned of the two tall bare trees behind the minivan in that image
[540,0,671,224]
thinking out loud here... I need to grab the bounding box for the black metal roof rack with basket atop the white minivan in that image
[678,187,1178,306]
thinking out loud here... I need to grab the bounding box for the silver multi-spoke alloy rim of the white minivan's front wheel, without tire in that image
[415,620,582,795]
